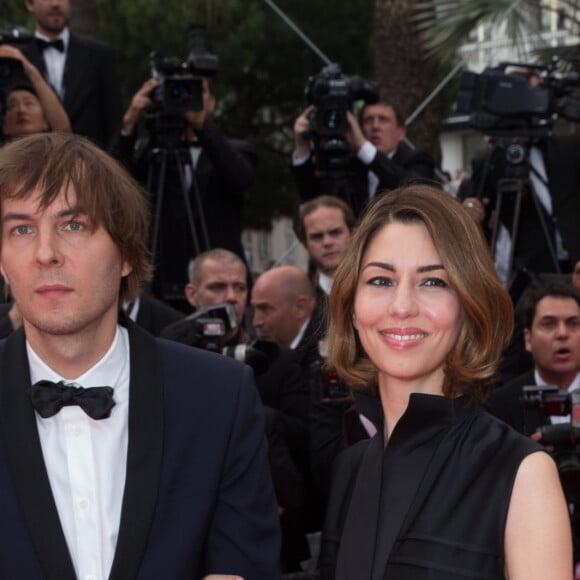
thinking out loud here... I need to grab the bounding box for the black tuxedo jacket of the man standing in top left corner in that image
[22,33,123,147]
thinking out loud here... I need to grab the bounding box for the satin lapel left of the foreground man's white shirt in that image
[0,329,76,580]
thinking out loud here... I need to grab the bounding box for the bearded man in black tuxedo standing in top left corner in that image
[22,0,122,147]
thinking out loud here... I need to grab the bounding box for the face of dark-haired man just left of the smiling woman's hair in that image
[304,207,351,276]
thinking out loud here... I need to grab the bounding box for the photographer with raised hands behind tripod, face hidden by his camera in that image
[112,47,256,299]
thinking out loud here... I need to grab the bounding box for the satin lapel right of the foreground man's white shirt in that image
[109,321,163,580]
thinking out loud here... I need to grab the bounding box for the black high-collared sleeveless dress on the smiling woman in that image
[320,394,543,580]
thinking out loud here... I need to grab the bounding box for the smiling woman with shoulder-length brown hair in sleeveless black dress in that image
[321,186,572,580]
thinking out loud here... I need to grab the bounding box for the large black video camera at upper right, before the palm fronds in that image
[456,59,580,136]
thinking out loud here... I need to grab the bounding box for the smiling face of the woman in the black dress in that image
[354,222,462,394]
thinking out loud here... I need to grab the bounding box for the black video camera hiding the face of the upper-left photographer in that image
[150,24,218,115]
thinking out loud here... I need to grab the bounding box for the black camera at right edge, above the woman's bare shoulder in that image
[522,385,580,494]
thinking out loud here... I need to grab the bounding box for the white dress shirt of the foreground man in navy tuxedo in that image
[27,326,130,580]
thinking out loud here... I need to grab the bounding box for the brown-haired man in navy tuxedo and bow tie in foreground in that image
[0,133,280,580]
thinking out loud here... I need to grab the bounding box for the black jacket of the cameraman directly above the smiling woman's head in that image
[292,146,435,217]
